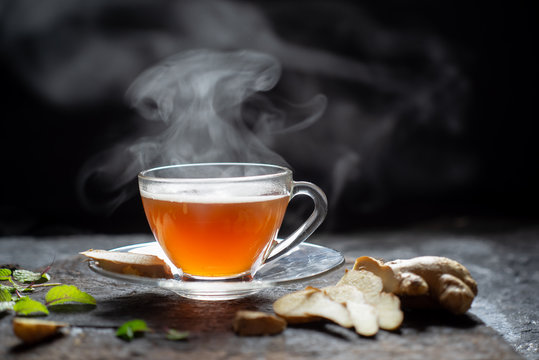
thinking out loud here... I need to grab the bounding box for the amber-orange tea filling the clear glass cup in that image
[142,193,288,277]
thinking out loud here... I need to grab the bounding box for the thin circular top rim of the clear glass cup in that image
[138,162,292,183]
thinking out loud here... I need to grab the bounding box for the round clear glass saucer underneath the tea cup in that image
[88,242,344,300]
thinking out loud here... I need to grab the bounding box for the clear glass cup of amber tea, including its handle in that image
[138,163,327,281]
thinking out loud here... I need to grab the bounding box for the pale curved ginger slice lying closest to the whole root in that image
[337,270,404,330]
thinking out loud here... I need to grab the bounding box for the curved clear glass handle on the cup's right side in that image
[264,181,328,264]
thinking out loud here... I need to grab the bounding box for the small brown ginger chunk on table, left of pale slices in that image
[233,310,286,336]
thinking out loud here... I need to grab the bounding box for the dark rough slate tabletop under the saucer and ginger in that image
[0,219,539,360]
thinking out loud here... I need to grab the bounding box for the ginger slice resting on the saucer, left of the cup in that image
[80,249,173,279]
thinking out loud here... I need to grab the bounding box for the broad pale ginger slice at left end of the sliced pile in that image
[273,287,353,327]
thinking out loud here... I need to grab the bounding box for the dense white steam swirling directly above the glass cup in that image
[79,50,326,211]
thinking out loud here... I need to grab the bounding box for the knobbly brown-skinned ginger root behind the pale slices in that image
[353,256,477,314]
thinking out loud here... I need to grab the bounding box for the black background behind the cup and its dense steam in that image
[0,0,539,235]
